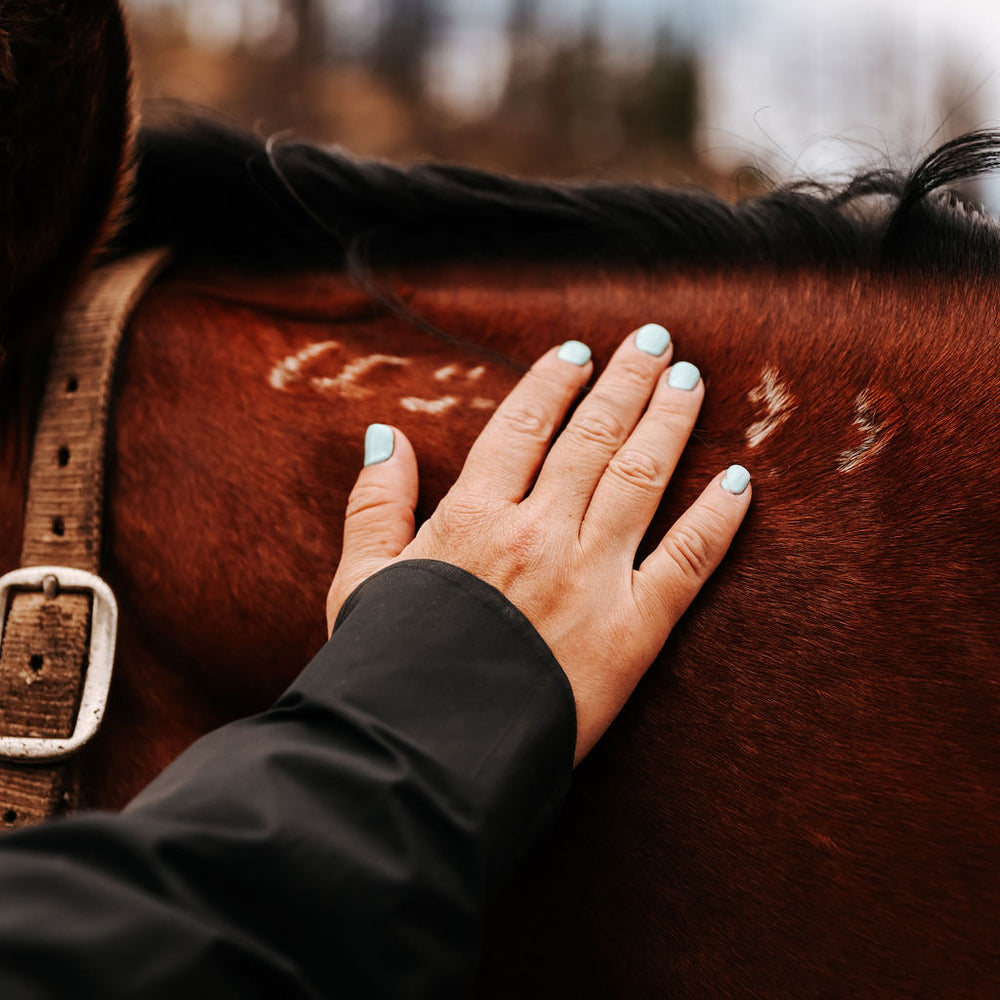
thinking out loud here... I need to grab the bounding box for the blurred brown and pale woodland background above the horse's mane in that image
[126,0,1000,210]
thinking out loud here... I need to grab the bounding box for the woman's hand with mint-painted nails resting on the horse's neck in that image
[326,325,750,763]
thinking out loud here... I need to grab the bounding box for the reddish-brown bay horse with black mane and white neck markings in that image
[0,0,1000,1000]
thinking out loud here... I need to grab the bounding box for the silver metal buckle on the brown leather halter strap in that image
[0,566,118,764]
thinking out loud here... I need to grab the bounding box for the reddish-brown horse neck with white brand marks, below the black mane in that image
[27,254,1000,1000]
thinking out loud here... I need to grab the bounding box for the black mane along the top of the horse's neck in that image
[116,117,1000,274]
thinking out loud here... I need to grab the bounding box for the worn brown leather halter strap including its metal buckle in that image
[0,250,168,831]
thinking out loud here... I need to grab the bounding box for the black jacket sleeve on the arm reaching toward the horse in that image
[0,560,575,1000]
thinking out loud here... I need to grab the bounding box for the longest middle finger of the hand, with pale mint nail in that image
[532,323,673,520]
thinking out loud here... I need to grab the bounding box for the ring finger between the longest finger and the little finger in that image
[580,361,705,552]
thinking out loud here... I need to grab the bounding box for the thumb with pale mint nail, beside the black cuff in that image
[326,424,417,631]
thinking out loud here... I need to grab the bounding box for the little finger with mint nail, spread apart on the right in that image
[632,465,752,632]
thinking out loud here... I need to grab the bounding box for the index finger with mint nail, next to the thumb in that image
[452,340,593,502]
